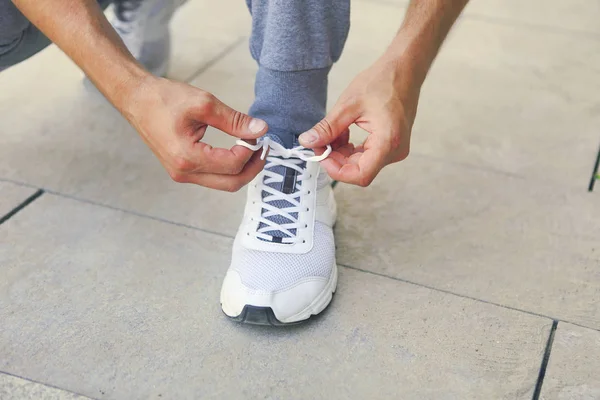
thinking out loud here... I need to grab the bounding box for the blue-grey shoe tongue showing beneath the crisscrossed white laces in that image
[259,135,306,243]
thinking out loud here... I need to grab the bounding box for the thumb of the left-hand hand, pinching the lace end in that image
[206,98,268,139]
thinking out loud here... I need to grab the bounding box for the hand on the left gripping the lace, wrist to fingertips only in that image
[121,76,267,192]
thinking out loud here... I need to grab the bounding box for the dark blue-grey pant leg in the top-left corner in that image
[0,0,111,71]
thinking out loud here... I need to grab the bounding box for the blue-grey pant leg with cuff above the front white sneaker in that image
[246,0,350,147]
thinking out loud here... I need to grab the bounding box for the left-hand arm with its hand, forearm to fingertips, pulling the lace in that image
[13,0,267,191]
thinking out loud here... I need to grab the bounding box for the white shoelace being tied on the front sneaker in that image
[236,137,331,244]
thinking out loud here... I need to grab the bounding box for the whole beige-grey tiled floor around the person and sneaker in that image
[0,0,600,400]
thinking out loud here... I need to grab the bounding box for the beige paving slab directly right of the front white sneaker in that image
[336,156,600,328]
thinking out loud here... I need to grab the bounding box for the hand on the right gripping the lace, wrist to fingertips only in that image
[300,59,419,186]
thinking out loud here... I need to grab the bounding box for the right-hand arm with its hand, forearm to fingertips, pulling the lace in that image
[299,0,468,186]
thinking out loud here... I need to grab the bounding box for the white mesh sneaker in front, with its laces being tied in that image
[221,137,337,325]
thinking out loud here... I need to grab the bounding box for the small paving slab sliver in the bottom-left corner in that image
[0,373,88,400]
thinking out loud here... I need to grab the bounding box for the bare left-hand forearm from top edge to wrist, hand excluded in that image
[13,0,148,111]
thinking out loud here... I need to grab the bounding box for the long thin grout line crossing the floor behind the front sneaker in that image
[0,179,600,332]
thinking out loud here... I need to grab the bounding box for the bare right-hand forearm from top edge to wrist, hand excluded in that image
[382,0,468,87]
